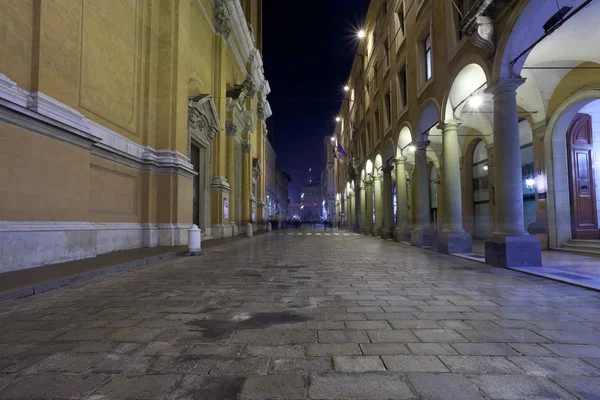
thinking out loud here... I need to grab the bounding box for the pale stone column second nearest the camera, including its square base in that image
[438,121,473,253]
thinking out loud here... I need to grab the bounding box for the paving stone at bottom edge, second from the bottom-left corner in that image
[94,375,181,400]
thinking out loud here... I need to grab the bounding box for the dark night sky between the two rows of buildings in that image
[263,0,369,203]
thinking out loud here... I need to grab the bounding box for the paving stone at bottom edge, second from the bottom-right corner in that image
[470,375,575,400]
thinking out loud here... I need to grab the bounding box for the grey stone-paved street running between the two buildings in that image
[0,230,600,400]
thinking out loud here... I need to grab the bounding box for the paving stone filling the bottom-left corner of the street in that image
[0,373,108,399]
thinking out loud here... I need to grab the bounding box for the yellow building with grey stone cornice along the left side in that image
[0,0,271,272]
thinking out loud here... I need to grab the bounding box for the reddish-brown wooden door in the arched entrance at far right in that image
[567,114,600,239]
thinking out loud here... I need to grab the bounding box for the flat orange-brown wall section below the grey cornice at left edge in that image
[0,124,90,221]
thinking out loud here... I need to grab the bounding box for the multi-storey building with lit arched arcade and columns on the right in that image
[334,0,600,266]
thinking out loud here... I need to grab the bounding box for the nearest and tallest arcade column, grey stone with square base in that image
[485,78,542,267]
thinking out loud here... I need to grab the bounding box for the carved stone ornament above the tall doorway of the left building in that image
[188,94,221,146]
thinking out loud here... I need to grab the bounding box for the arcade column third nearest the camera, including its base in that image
[410,142,435,246]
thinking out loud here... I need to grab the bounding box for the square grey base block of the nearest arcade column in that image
[485,235,542,267]
